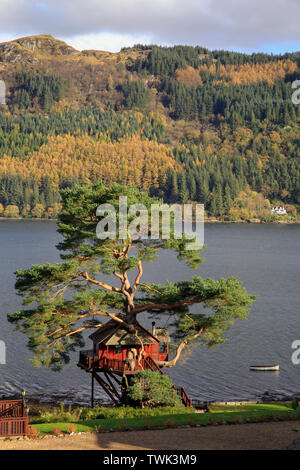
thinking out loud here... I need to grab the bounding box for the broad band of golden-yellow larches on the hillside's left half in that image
[0,135,178,189]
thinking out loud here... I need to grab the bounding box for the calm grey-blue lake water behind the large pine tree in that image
[0,220,300,402]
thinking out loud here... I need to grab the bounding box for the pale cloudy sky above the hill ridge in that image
[0,0,300,54]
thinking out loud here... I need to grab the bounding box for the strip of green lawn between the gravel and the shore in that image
[32,402,300,434]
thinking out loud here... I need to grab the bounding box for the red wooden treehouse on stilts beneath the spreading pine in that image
[77,320,192,406]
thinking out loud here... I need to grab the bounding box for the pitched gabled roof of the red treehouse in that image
[89,320,169,346]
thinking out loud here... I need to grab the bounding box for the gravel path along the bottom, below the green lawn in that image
[0,421,300,450]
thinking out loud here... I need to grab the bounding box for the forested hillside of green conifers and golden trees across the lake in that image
[0,35,300,221]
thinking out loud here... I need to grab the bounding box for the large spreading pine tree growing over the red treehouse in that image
[9,184,254,368]
